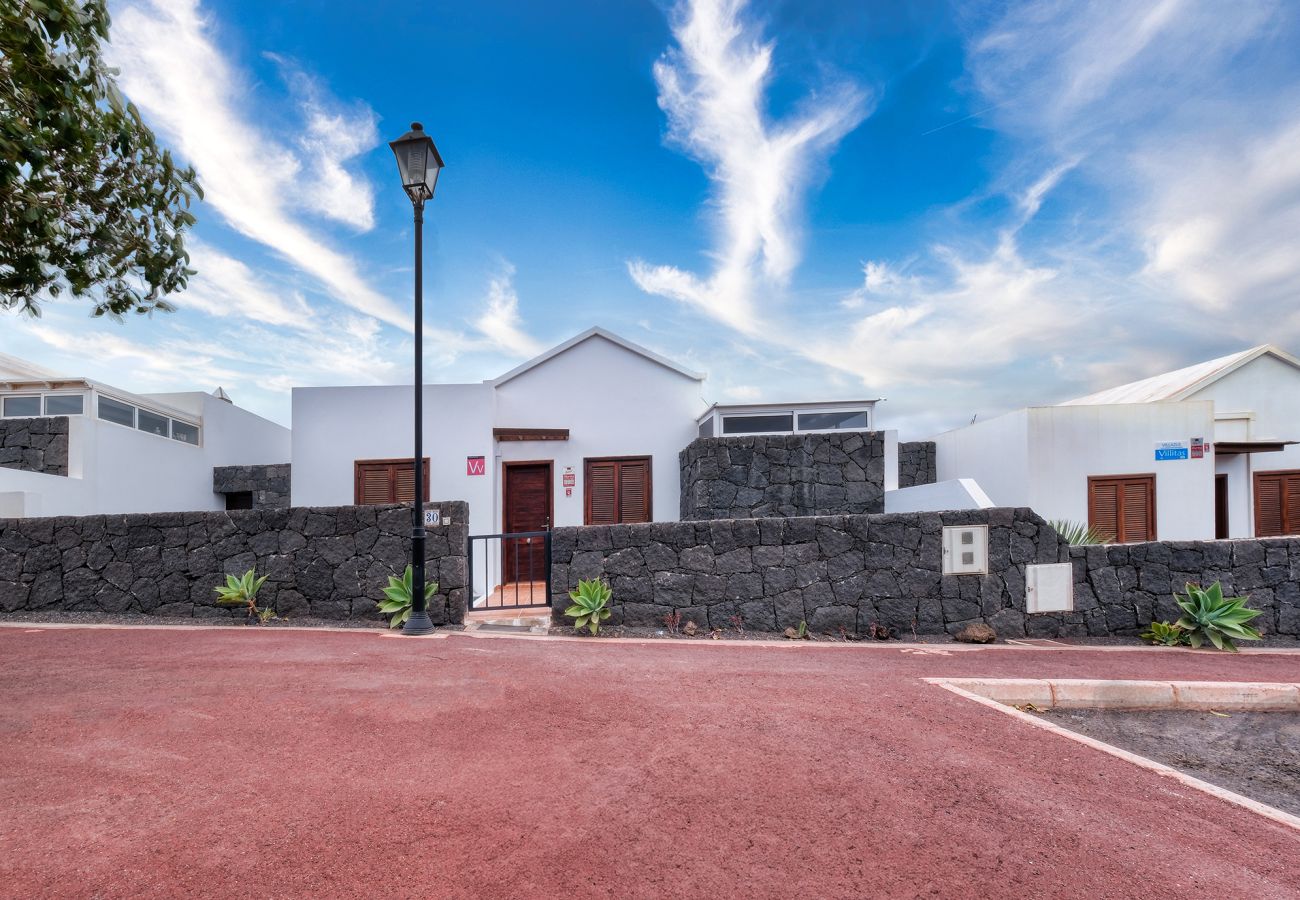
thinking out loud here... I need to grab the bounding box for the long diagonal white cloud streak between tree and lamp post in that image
[109,0,411,330]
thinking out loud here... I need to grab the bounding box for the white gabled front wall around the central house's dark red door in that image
[495,337,707,525]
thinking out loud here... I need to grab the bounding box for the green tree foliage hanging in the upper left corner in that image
[0,0,202,316]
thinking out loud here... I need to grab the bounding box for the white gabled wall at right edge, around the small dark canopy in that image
[1192,355,1300,537]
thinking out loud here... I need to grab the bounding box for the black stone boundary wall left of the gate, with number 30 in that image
[0,501,469,624]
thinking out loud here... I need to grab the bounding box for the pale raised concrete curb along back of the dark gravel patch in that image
[926,678,1300,711]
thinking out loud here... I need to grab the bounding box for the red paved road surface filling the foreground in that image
[0,628,1300,900]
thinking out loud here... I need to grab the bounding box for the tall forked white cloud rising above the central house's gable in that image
[628,0,868,334]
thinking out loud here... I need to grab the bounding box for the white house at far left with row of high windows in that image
[0,355,290,518]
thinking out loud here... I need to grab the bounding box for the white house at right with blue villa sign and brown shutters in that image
[935,346,1300,542]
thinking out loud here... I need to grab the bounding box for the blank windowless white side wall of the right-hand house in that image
[935,410,1030,506]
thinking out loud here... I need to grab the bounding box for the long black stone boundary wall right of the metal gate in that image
[551,509,1300,637]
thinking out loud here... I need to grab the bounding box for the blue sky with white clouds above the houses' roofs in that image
[0,0,1300,437]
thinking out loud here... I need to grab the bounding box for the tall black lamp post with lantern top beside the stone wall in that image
[389,122,442,635]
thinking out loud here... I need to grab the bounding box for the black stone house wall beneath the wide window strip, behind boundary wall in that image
[679,432,885,520]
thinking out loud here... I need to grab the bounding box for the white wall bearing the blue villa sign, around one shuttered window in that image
[1024,401,1214,541]
